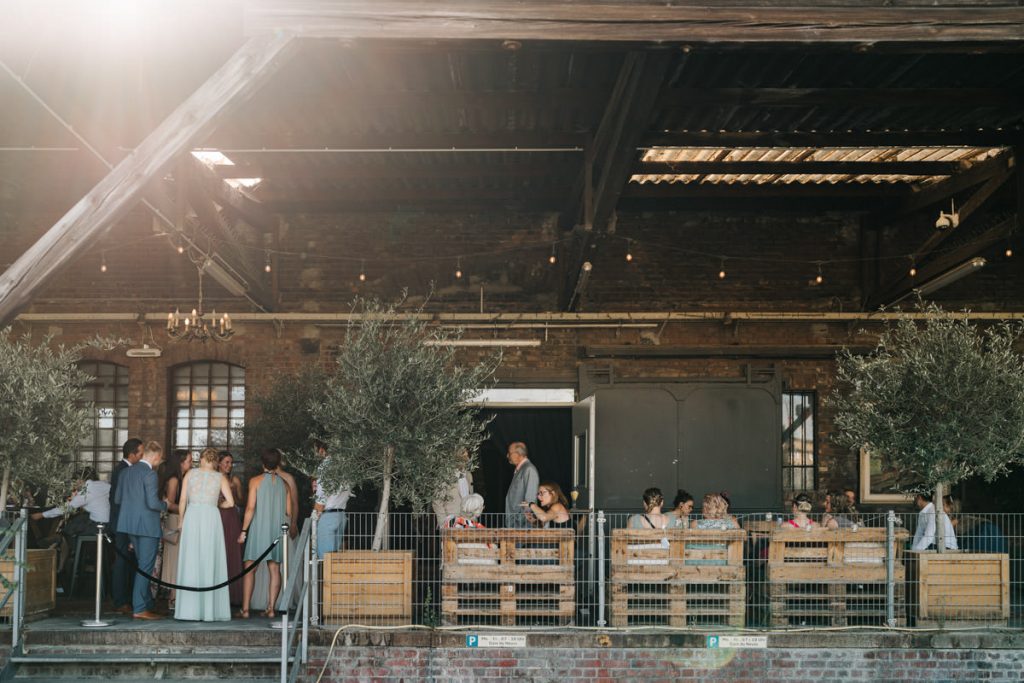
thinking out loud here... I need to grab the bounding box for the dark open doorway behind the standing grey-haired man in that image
[473,408,572,516]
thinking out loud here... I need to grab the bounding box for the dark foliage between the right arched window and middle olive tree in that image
[244,364,328,476]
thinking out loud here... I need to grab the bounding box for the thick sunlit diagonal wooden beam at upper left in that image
[0,34,294,326]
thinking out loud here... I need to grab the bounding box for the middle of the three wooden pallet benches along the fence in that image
[610,528,746,627]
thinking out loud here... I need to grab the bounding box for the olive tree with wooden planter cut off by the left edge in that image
[0,329,91,613]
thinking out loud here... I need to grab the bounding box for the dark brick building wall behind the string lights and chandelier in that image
[0,205,1024,505]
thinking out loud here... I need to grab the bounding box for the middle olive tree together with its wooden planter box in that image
[313,300,500,623]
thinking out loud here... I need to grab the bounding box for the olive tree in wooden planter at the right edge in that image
[831,304,1024,623]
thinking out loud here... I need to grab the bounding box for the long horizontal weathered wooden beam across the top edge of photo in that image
[245,0,1024,44]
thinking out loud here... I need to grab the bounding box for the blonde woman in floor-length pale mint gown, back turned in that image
[174,449,234,622]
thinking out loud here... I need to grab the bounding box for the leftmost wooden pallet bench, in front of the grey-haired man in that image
[441,528,575,626]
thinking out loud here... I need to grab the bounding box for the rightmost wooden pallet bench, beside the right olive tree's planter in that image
[767,528,907,627]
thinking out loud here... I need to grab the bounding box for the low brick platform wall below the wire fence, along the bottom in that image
[306,631,1024,683]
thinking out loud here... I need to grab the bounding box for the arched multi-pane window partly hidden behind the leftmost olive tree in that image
[75,360,128,478]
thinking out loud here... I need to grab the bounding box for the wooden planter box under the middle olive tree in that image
[322,550,413,626]
